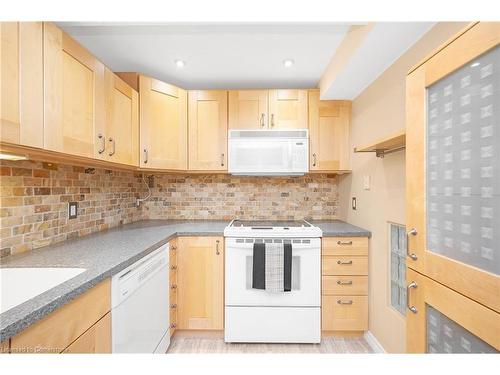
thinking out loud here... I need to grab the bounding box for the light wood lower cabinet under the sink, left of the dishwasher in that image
[10,279,111,353]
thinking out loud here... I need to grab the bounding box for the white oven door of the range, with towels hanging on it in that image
[225,238,321,307]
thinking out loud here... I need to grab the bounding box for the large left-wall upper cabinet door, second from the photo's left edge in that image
[44,23,105,157]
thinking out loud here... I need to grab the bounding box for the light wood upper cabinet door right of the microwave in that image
[309,90,351,171]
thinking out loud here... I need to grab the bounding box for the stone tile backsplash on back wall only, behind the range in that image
[146,174,338,220]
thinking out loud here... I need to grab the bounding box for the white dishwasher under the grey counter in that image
[111,244,170,353]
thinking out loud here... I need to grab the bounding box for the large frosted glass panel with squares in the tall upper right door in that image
[426,47,500,275]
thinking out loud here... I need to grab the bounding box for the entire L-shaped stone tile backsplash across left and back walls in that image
[0,160,338,257]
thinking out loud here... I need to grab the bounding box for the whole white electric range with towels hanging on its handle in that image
[224,220,322,343]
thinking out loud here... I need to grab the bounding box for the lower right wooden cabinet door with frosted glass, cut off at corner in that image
[406,268,500,353]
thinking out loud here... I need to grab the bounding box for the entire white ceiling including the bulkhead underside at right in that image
[58,22,433,99]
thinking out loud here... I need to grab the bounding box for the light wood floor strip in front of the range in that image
[167,332,374,354]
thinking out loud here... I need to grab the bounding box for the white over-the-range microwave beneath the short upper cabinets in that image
[228,129,309,176]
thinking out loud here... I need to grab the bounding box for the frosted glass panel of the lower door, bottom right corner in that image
[426,305,498,353]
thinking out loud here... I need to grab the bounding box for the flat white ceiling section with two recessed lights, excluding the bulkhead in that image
[58,22,350,89]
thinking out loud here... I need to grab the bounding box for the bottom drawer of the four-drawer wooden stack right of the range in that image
[321,296,368,331]
